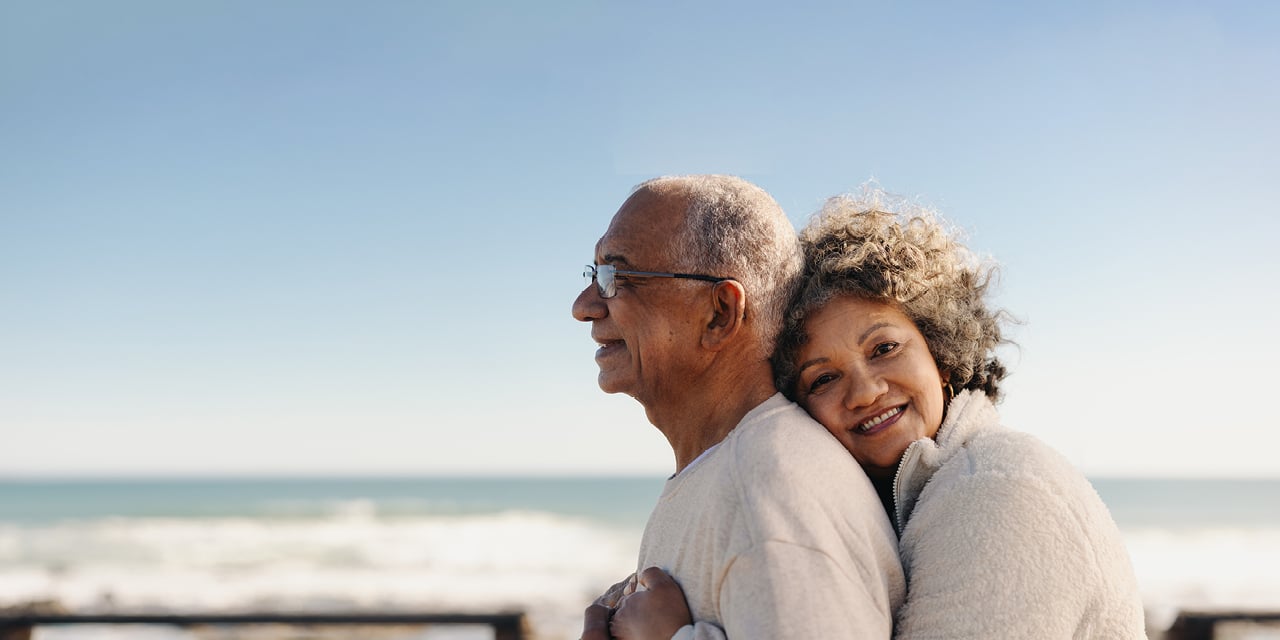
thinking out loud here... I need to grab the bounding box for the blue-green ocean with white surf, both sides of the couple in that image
[0,477,1280,640]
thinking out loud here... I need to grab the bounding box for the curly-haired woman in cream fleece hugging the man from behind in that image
[612,192,1146,640]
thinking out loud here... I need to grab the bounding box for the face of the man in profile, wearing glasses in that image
[573,189,710,407]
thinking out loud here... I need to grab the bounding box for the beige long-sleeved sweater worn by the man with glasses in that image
[639,394,905,640]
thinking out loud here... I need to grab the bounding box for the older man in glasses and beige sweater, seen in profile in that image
[573,175,904,640]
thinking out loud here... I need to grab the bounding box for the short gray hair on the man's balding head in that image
[636,175,804,357]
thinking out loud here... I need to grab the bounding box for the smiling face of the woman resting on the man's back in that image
[796,296,943,477]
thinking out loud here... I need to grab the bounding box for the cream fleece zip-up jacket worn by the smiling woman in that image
[893,390,1146,640]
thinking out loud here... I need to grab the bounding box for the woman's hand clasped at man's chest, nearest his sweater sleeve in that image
[609,567,694,640]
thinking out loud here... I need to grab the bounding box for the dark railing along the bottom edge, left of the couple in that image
[0,613,529,640]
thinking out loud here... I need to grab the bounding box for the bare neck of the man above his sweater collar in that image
[646,375,777,474]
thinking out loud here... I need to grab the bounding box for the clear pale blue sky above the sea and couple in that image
[0,0,1280,477]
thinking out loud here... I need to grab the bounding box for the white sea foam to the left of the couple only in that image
[0,508,639,637]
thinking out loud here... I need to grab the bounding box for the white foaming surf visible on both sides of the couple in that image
[0,500,1280,637]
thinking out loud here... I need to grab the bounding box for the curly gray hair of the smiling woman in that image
[773,187,1006,402]
